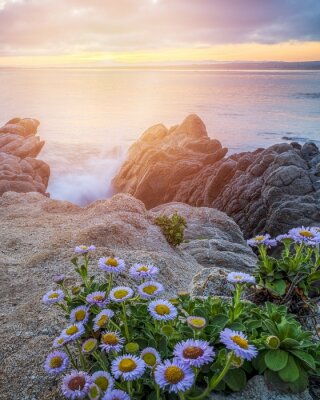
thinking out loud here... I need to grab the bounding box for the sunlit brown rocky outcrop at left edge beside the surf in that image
[0,118,50,196]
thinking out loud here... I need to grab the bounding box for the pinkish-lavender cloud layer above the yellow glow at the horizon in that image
[0,0,320,56]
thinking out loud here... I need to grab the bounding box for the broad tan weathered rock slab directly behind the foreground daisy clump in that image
[0,192,255,400]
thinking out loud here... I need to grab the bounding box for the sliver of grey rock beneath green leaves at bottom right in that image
[209,375,312,400]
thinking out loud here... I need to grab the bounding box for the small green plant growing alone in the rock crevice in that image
[155,212,187,246]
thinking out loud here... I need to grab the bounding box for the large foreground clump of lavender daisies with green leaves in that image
[43,246,320,400]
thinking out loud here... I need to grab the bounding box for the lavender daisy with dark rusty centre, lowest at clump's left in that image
[61,371,92,400]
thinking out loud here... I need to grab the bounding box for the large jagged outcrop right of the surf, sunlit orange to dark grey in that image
[113,115,320,237]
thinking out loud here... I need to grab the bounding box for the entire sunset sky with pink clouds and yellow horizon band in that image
[0,0,320,67]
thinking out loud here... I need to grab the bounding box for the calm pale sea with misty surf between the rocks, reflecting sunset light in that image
[0,69,320,204]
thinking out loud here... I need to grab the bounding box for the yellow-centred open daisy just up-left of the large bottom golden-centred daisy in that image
[111,354,146,381]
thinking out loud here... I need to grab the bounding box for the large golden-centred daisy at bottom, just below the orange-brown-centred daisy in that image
[154,359,195,393]
